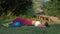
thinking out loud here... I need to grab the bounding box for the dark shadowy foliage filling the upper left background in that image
[0,0,33,16]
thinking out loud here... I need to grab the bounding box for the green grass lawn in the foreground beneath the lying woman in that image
[0,24,60,34]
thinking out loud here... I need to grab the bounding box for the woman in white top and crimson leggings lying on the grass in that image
[9,18,48,27]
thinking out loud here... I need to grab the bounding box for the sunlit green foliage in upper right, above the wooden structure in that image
[44,0,60,17]
